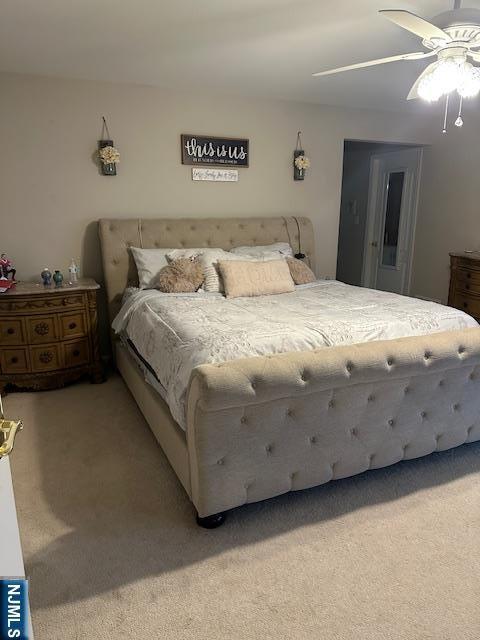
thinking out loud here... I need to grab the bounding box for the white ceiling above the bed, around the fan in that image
[0,0,480,110]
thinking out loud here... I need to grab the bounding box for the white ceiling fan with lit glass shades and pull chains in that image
[312,0,480,131]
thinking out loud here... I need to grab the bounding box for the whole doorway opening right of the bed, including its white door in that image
[337,141,422,295]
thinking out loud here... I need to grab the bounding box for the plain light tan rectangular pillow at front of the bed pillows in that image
[218,260,295,298]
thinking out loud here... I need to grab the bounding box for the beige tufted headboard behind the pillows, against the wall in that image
[99,217,315,322]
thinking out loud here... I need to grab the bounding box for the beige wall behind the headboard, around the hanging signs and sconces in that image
[0,74,436,352]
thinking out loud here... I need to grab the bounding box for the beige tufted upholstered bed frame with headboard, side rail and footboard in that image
[100,217,480,527]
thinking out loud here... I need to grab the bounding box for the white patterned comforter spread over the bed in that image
[112,280,477,428]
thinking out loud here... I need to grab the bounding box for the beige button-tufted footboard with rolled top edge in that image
[187,328,480,517]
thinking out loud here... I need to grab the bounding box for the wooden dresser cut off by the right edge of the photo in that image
[448,251,480,322]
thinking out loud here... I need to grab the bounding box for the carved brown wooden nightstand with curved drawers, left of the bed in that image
[0,278,104,391]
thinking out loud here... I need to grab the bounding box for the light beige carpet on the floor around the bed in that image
[6,376,480,640]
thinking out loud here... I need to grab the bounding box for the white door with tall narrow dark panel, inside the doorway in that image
[362,148,422,294]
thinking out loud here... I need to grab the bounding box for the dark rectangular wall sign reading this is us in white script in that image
[181,133,248,167]
